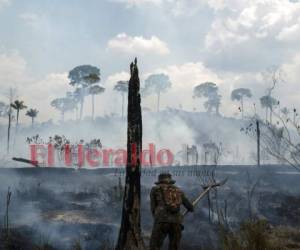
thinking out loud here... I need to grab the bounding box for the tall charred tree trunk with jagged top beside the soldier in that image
[115,59,145,250]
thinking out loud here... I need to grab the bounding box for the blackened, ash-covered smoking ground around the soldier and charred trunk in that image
[0,166,300,250]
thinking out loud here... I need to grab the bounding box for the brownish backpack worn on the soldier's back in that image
[160,185,182,213]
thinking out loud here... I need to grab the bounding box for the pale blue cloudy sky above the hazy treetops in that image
[0,0,300,122]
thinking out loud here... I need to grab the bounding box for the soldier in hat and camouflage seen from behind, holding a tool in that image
[150,173,194,250]
